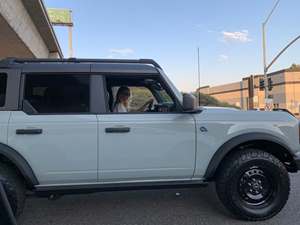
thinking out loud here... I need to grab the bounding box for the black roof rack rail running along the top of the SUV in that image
[0,58,161,69]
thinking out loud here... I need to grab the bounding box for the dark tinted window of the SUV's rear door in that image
[24,75,90,114]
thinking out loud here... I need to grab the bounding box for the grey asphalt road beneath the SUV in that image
[19,174,300,225]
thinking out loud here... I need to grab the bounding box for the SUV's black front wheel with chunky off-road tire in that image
[216,149,290,221]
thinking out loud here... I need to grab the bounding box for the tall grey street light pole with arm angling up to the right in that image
[262,0,280,101]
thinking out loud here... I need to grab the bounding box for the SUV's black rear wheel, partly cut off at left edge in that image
[0,162,26,217]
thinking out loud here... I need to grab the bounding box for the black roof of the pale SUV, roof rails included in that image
[0,58,161,75]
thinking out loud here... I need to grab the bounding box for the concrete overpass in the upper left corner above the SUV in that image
[0,0,63,58]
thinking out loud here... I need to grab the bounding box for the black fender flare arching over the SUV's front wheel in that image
[204,132,294,180]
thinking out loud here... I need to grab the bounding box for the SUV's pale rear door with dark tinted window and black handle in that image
[8,65,98,185]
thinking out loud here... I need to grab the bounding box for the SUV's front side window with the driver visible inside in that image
[106,76,177,113]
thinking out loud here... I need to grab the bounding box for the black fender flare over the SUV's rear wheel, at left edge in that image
[0,143,39,188]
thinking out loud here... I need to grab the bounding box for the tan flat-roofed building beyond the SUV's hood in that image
[200,70,300,115]
